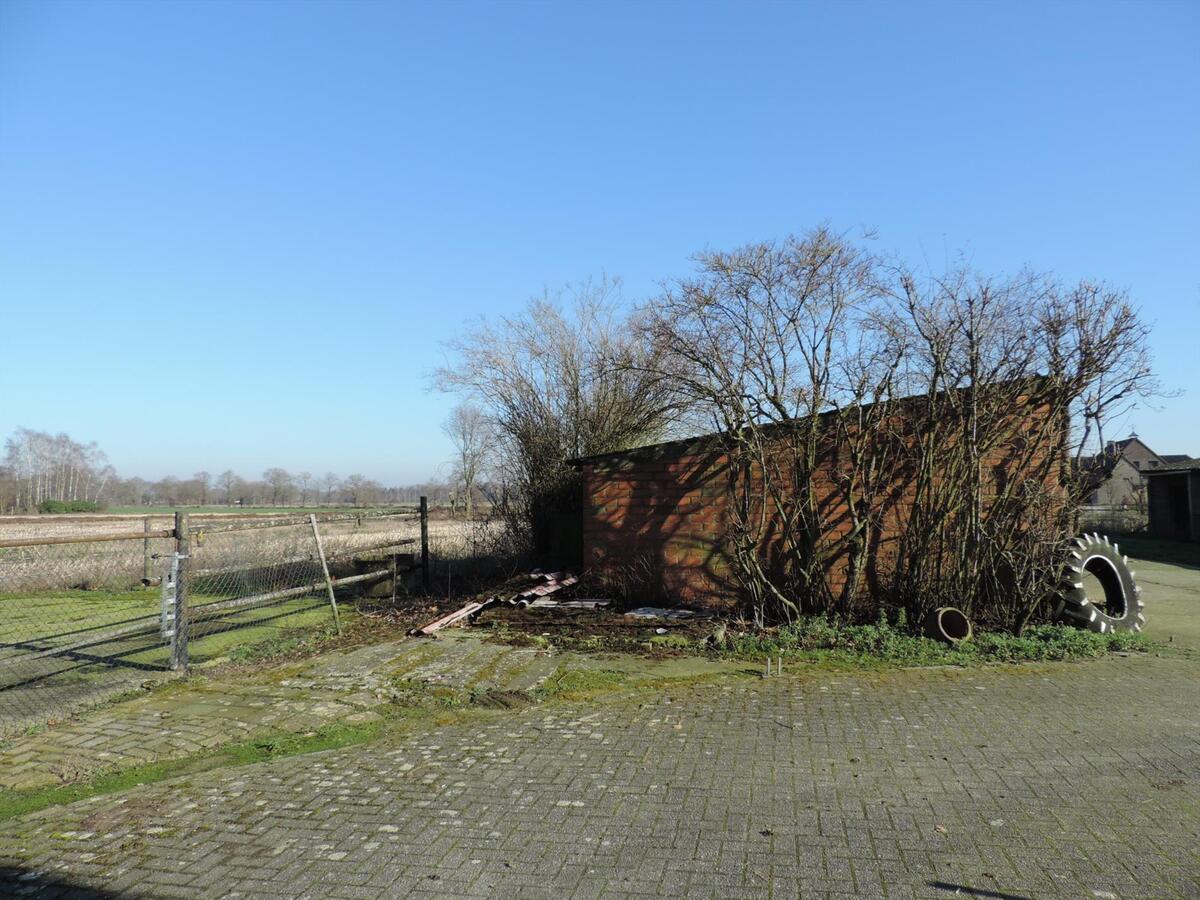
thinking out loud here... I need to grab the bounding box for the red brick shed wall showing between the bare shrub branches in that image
[582,400,1060,608]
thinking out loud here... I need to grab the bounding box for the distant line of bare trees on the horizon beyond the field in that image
[0,428,458,514]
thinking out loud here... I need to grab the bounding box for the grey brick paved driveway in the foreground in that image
[0,658,1200,898]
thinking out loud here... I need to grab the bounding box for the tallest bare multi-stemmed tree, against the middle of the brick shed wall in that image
[647,228,901,623]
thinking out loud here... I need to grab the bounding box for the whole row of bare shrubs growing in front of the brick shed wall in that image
[640,228,1158,631]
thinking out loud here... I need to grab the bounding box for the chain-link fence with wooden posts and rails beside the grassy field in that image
[0,503,428,738]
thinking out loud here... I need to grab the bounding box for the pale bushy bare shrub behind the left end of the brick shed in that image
[436,278,686,564]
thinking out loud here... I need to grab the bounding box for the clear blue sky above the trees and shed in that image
[0,0,1200,482]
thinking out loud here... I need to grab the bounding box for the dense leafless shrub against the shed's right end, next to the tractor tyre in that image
[889,270,1159,632]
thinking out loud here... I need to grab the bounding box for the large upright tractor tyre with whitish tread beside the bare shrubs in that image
[1058,534,1146,634]
